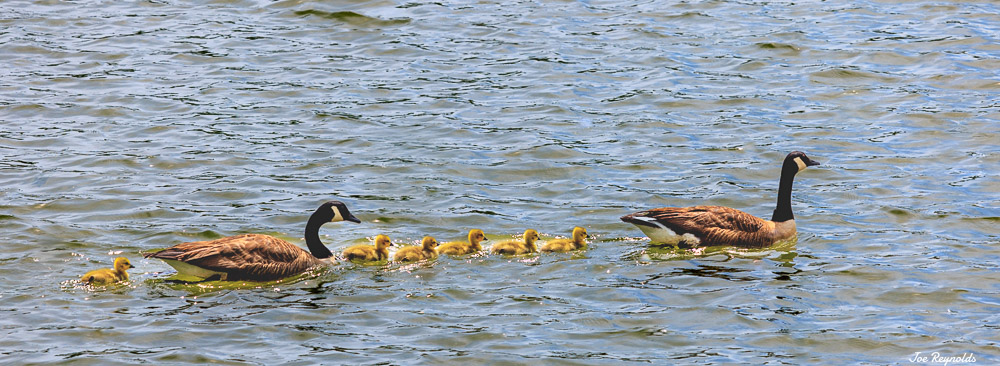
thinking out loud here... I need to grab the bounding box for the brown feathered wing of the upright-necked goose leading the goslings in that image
[644,206,773,248]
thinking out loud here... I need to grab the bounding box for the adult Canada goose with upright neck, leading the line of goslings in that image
[621,151,819,248]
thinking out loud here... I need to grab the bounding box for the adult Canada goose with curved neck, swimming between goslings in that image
[143,201,361,281]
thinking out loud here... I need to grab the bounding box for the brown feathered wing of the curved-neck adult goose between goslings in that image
[147,234,318,281]
